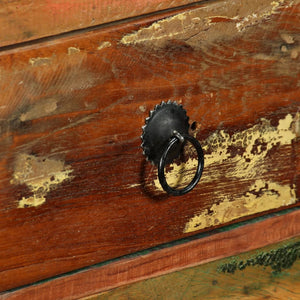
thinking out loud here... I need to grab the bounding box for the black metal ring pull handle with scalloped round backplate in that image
[141,101,204,196]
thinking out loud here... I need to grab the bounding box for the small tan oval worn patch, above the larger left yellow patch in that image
[20,98,57,122]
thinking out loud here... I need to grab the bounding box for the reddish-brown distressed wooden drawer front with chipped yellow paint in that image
[0,0,300,290]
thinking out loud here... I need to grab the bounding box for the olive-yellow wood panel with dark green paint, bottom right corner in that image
[84,239,300,300]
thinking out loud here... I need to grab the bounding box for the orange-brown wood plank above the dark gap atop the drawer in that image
[0,0,201,47]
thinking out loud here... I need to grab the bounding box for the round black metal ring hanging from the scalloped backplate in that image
[158,134,204,196]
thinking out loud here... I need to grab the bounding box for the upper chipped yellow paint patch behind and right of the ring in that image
[154,114,299,191]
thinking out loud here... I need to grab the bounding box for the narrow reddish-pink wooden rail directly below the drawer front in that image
[0,210,300,300]
